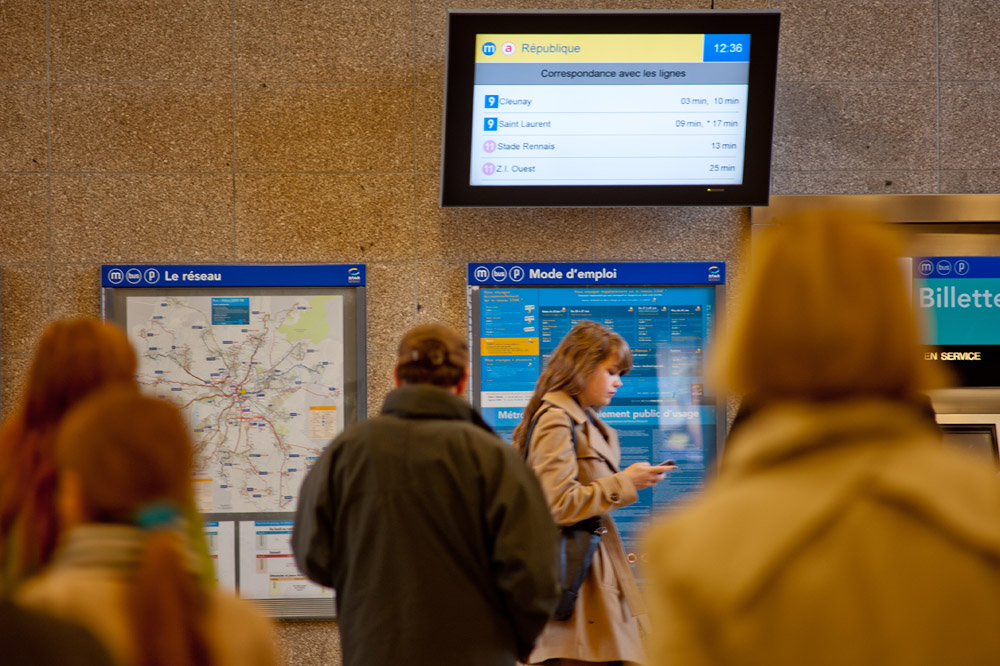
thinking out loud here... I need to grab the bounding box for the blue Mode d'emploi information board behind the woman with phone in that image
[468,262,725,562]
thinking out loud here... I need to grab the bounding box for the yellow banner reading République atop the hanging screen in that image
[476,34,705,64]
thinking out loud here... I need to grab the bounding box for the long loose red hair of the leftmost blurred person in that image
[0,318,136,585]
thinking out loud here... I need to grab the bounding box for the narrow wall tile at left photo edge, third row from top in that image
[0,174,49,263]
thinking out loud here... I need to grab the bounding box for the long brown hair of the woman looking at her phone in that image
[513,320,632,451]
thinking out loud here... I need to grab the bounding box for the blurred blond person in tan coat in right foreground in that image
[648,212,1000,666]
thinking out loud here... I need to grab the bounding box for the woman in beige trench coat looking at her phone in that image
[514,321,673,665]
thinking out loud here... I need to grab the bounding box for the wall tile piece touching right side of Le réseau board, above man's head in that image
[365,263,417,353]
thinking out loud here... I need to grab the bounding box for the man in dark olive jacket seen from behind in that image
[292,324,559,666]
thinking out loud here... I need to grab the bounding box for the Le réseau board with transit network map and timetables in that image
[101,265,365,617]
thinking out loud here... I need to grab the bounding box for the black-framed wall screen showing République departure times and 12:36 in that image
[441,11,780,206]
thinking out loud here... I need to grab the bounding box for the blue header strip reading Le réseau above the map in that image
[101,264,365,288]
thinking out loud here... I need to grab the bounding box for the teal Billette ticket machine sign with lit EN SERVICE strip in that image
[912,257,1000,387]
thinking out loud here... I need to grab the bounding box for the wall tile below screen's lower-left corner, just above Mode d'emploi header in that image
[416,175,595,262]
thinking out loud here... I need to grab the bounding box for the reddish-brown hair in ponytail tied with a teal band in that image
[56,387,211,666]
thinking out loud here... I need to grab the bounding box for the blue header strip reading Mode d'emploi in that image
[469,261,726,286]
